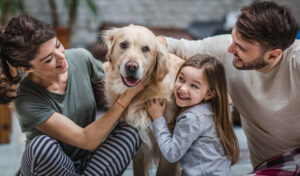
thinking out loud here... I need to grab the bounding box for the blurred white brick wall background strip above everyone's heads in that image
[0,0,300,52]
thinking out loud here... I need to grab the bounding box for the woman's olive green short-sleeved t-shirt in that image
[15,49,104,161]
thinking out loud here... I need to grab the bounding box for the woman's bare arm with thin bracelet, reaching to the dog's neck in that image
[37,82,144,150]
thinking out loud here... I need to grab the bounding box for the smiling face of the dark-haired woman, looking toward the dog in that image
[30,37,68,76]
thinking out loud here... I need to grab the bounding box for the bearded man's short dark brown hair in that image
[235,1,297,50]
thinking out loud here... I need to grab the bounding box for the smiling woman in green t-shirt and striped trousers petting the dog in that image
[0,15,145,175]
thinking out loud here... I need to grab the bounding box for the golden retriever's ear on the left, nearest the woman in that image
[102,28,119,62]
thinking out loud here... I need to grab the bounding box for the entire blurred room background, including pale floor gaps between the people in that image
[0,0,300,176]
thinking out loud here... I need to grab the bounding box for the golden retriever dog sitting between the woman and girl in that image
[104,25,183,176]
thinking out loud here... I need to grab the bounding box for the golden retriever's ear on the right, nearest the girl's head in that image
[155,41,169,82]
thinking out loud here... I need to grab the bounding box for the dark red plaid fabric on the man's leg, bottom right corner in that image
[248,148,300,176]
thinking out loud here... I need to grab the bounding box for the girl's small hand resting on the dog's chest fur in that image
[146,98,166,120]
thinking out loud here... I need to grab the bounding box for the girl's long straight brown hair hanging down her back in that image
[177,54,240,165]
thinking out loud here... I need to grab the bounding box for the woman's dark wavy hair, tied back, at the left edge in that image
[0,15,56,104]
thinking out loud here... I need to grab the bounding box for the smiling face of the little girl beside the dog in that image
[174,66,213,107]
